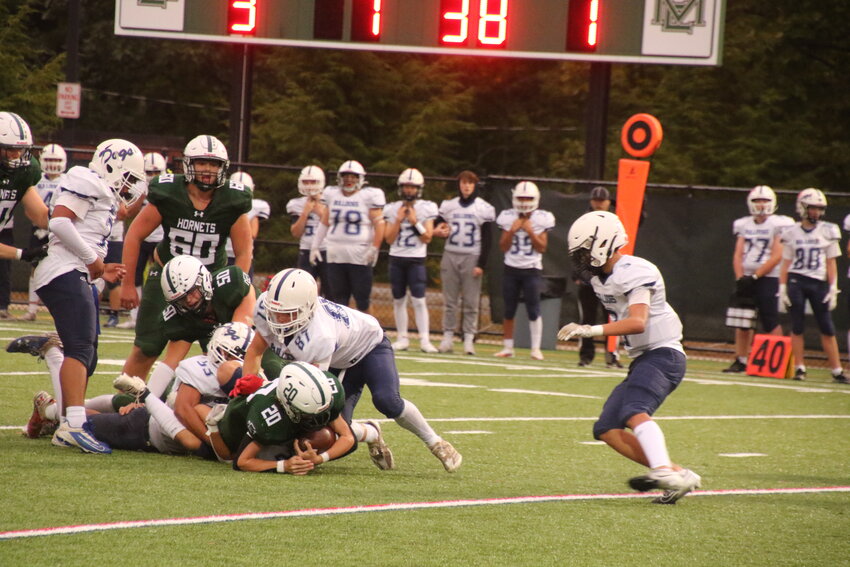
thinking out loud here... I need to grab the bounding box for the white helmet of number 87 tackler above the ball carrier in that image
[266,268,319,340]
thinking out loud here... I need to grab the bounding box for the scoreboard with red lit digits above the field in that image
[115,0,726,65]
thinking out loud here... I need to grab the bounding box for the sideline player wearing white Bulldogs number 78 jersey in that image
[310,160,387,313]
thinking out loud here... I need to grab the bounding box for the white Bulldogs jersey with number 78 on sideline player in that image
[322,186,387,266]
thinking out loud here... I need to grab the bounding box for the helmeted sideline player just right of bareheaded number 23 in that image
[496,181,555,360]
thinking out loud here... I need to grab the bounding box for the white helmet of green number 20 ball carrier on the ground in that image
[277,362,339,429]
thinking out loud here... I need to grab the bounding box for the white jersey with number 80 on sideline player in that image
[782,221,841,281]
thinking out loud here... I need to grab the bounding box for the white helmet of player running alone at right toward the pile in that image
[567,211,629,274]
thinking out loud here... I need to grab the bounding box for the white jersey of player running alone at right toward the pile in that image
[590,255,685,358]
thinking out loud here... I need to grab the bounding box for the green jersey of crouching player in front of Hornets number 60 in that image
[162,266,254,342]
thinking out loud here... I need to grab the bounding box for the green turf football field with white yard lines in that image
[0,322,850,567]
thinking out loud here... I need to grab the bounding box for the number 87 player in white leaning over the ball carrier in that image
[238,269,462,472]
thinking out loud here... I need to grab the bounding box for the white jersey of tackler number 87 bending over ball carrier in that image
[254,293,384,370]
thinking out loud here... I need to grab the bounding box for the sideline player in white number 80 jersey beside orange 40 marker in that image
[779,187,850,384]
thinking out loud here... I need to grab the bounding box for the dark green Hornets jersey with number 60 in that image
[148,173,253,271]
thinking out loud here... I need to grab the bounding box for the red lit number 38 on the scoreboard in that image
[439,0,510,48]
